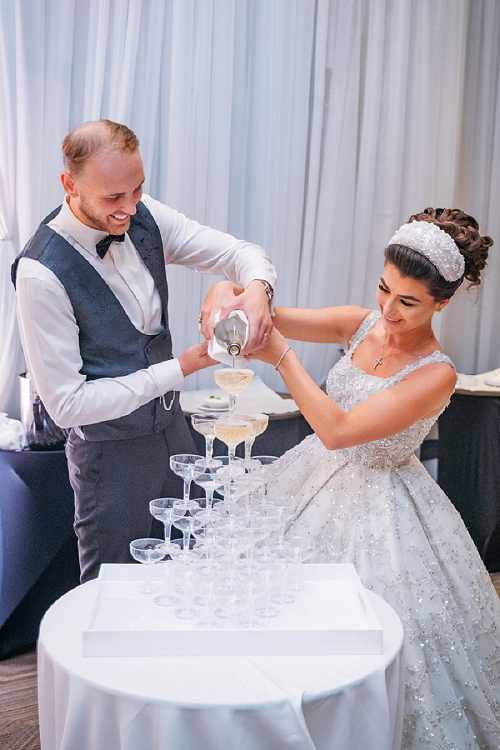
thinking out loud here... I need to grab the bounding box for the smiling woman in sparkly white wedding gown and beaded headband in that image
[240,208,500,750]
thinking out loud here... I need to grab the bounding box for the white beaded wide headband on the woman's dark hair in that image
[389,221,465,281]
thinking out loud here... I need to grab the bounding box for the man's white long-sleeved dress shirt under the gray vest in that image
[17,195,276,434]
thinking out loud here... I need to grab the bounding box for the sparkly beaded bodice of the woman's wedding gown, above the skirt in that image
[326,310,453,468]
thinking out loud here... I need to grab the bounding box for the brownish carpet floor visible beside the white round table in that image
[0,573,500,750]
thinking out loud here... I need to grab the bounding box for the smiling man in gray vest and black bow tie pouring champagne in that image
[13,120,275,582]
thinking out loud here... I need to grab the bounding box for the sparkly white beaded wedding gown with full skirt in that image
[276,311,500,750]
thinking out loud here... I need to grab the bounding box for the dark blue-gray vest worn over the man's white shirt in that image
[12,202,180,440]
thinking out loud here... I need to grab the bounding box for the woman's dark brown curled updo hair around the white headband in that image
[385,208,493,302]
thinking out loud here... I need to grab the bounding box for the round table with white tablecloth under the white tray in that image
[38,581,404,750]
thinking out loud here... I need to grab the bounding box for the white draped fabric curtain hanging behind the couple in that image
[0,0,500,415]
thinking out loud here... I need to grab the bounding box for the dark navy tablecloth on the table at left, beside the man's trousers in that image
[0,451,79,658]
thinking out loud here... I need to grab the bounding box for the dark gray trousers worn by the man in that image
[66,409,197,583]
